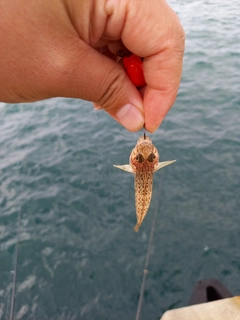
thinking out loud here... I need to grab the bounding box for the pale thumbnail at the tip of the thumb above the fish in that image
[116,104,144,131]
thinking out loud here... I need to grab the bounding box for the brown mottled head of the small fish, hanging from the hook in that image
[129,136,159,172]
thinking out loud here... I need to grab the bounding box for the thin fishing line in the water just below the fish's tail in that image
[135,174,160,320]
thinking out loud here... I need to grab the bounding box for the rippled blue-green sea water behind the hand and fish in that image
[0,0,240,320]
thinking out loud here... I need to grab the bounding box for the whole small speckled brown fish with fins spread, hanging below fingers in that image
[114,134,176,232]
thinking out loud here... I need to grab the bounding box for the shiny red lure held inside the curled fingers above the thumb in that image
[122,54,146,88]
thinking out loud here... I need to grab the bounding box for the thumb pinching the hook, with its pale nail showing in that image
[57,40,144,131]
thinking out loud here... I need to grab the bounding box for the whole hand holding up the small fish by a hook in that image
[0,0,184,132]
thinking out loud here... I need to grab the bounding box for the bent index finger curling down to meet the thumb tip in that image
[119,0,185,132]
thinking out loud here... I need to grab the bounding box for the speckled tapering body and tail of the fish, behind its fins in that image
[134,171,153,232]
